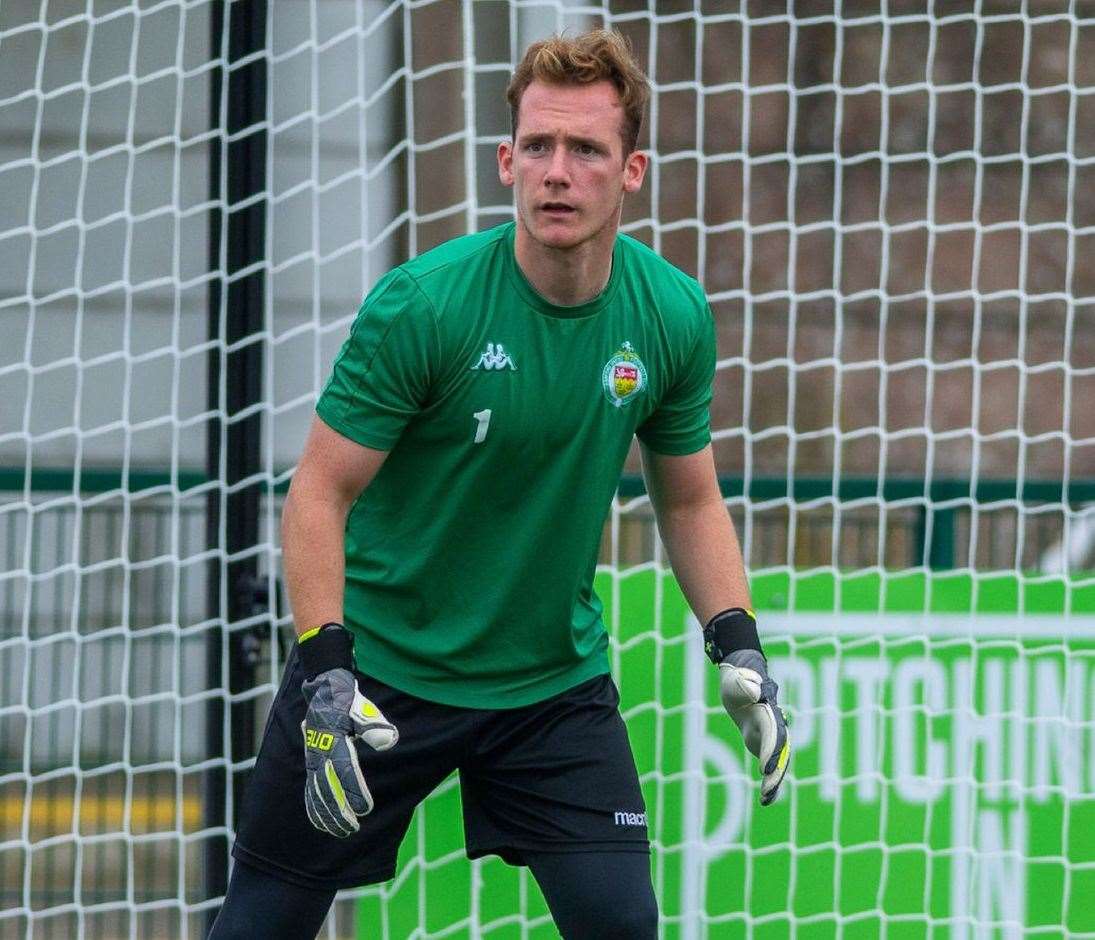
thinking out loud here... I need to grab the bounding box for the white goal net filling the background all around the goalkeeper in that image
[0,0,1095,940]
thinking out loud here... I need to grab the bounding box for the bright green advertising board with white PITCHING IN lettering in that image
[358,569,1095,940]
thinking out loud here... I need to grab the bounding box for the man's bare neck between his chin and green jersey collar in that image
[514,218,615,307]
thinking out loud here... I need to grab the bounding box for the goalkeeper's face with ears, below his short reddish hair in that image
[498,81,646,249]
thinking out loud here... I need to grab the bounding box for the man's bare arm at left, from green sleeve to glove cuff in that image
[281,417,388,633]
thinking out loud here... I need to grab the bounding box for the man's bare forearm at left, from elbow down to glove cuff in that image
[281,491,346,633]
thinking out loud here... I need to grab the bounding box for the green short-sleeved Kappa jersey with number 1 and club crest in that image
[316,223,715,708]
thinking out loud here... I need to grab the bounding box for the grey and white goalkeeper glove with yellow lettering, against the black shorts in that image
[299,623,400,838]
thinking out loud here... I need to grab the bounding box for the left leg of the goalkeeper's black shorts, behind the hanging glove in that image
[232,647,461,889]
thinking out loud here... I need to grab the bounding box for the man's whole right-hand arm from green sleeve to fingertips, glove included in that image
[643,445,791,804]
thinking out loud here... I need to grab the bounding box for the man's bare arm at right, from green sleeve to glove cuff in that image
[643,445,752,623]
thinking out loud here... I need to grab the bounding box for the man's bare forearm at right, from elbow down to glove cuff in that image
[658,498,752,624]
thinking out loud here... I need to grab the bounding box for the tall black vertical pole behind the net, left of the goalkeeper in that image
[204,0,267,927]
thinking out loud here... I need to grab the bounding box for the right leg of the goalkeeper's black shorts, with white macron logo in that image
[460,675,649,864]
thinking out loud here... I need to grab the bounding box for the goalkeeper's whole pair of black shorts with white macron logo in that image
[232,649,649,889]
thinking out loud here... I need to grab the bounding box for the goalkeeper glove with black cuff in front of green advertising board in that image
[703,607,791,806]
